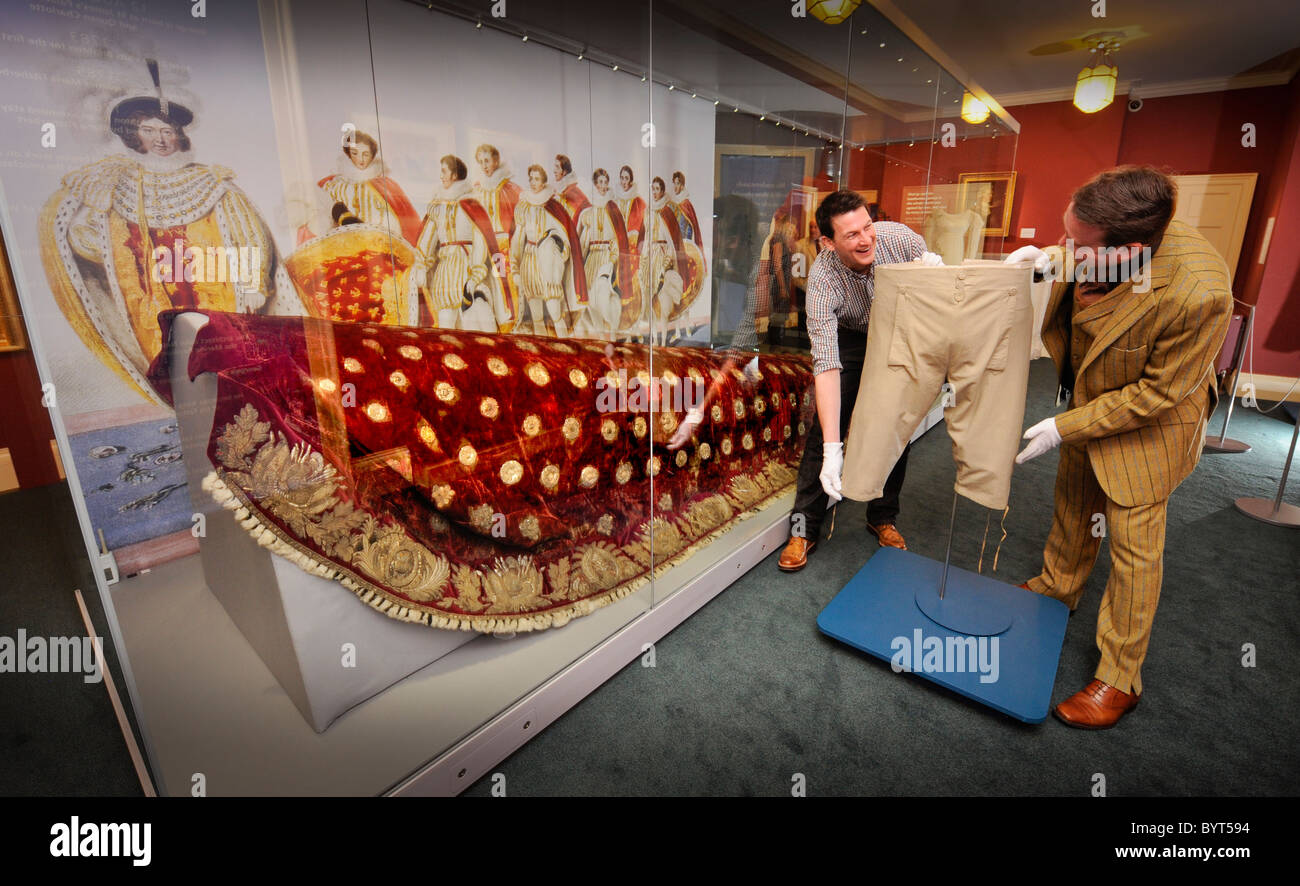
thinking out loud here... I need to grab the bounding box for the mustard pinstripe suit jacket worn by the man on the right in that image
[1043,221,1232,508]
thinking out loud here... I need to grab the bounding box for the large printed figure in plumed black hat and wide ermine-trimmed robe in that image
[39,58,303,403]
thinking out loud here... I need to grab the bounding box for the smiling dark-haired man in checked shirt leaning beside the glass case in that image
[777,191,943,572]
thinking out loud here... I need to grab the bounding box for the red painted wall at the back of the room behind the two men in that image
[850,78,1300,375]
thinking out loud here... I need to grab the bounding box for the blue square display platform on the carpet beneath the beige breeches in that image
[816,548,1070,722]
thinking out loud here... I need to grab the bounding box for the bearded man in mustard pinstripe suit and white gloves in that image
[1013,166,1232,729]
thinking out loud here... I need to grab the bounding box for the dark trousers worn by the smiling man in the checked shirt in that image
[790,330,911,542]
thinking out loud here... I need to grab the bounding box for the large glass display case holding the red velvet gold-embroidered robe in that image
[0,0,1017,795]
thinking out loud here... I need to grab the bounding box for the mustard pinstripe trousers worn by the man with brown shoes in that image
[1028,444,1169,694]
